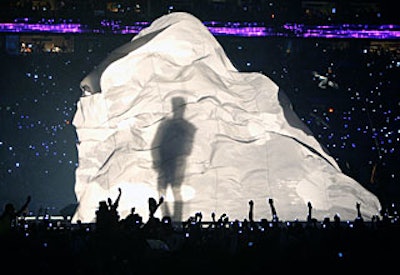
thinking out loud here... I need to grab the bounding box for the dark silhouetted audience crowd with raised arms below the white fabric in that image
[0,194,400,275]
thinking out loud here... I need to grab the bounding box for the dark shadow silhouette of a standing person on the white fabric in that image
[152,97,196,221]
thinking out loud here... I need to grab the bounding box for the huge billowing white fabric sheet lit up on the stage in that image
[72,12,381,222]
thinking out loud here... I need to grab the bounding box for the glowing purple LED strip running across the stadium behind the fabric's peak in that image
[0,20,400,40]
